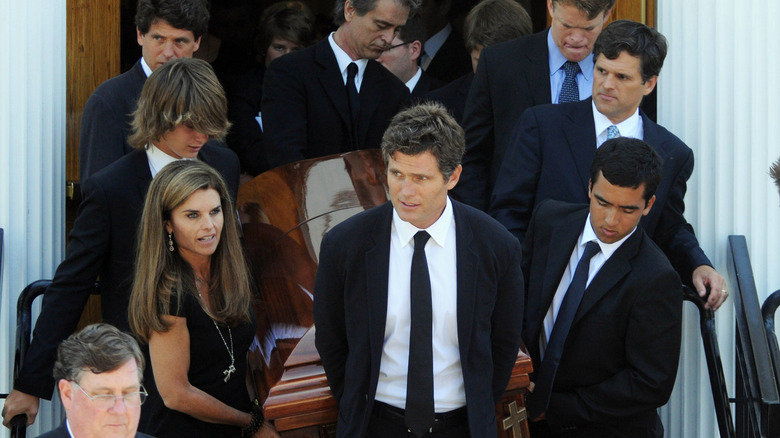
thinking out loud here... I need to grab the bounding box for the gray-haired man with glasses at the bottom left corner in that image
[40,324,149,438]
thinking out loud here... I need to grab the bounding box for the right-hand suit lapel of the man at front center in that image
[452,202,479,357]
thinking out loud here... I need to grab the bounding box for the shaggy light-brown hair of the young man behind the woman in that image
[127,58,230,149]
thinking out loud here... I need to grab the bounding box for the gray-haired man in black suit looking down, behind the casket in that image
[261,0,419,167]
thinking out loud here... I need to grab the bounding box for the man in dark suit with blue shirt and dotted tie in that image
[455,0,615,210]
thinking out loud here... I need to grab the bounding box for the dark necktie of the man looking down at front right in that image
[528,241,601,420]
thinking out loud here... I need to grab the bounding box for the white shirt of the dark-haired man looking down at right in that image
[539,213,636,358]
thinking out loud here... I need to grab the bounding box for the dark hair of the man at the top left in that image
[135,0,209,40]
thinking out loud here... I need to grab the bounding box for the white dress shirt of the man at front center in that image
[376,198,466,412]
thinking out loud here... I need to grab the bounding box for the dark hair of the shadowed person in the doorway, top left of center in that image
[257,0,315,53]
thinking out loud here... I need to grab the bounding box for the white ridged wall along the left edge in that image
[0,0,66,437]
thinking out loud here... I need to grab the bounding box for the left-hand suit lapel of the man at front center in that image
[365,202,393,371]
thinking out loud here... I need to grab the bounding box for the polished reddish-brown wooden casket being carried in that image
[237,150,531,438]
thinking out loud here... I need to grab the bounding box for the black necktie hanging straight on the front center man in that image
[406,231,435,437]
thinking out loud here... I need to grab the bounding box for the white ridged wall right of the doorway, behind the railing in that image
[656,0,780,438]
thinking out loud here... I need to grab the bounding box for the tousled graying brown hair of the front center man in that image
[382,102,466,179]
